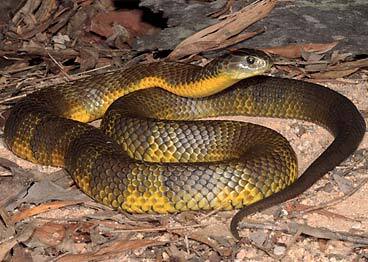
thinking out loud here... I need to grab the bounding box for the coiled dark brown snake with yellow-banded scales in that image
[4,49,366,239]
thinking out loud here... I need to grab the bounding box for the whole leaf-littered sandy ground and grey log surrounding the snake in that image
[0,0,368,262]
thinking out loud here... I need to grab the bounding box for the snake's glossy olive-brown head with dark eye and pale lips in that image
[214,49,272,80]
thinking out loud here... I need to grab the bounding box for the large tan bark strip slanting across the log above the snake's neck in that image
[169,0,277,59]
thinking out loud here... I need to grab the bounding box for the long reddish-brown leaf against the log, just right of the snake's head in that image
[262,42,338,58]
